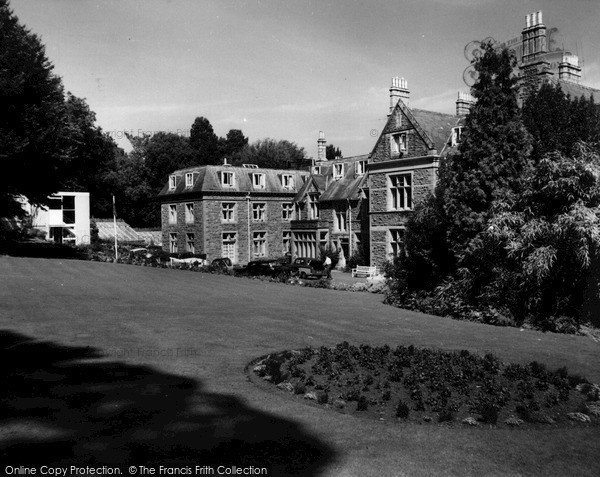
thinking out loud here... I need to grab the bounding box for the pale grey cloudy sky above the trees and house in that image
[11,0,600,157]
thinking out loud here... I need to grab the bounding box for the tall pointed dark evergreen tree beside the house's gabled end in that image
[440,43,531,258]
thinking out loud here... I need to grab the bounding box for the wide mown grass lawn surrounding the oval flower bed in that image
[0,257,600,476]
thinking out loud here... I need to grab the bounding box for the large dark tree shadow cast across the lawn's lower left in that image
[0,331,335,475]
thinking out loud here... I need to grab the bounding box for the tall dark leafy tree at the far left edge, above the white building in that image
[0,0,66,217]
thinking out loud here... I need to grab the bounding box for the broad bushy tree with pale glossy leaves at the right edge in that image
[478,143,600,330]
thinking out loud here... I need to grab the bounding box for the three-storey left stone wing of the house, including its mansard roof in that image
[159,166,309,263]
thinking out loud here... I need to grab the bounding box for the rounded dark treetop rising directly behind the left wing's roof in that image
[232,138,307,169]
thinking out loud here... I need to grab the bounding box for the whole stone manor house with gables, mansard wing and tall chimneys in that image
[159,12,600,266]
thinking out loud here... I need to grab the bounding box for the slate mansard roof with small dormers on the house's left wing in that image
[158,165,309,199]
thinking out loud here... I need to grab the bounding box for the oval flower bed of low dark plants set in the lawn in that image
[251,342,600,427]
